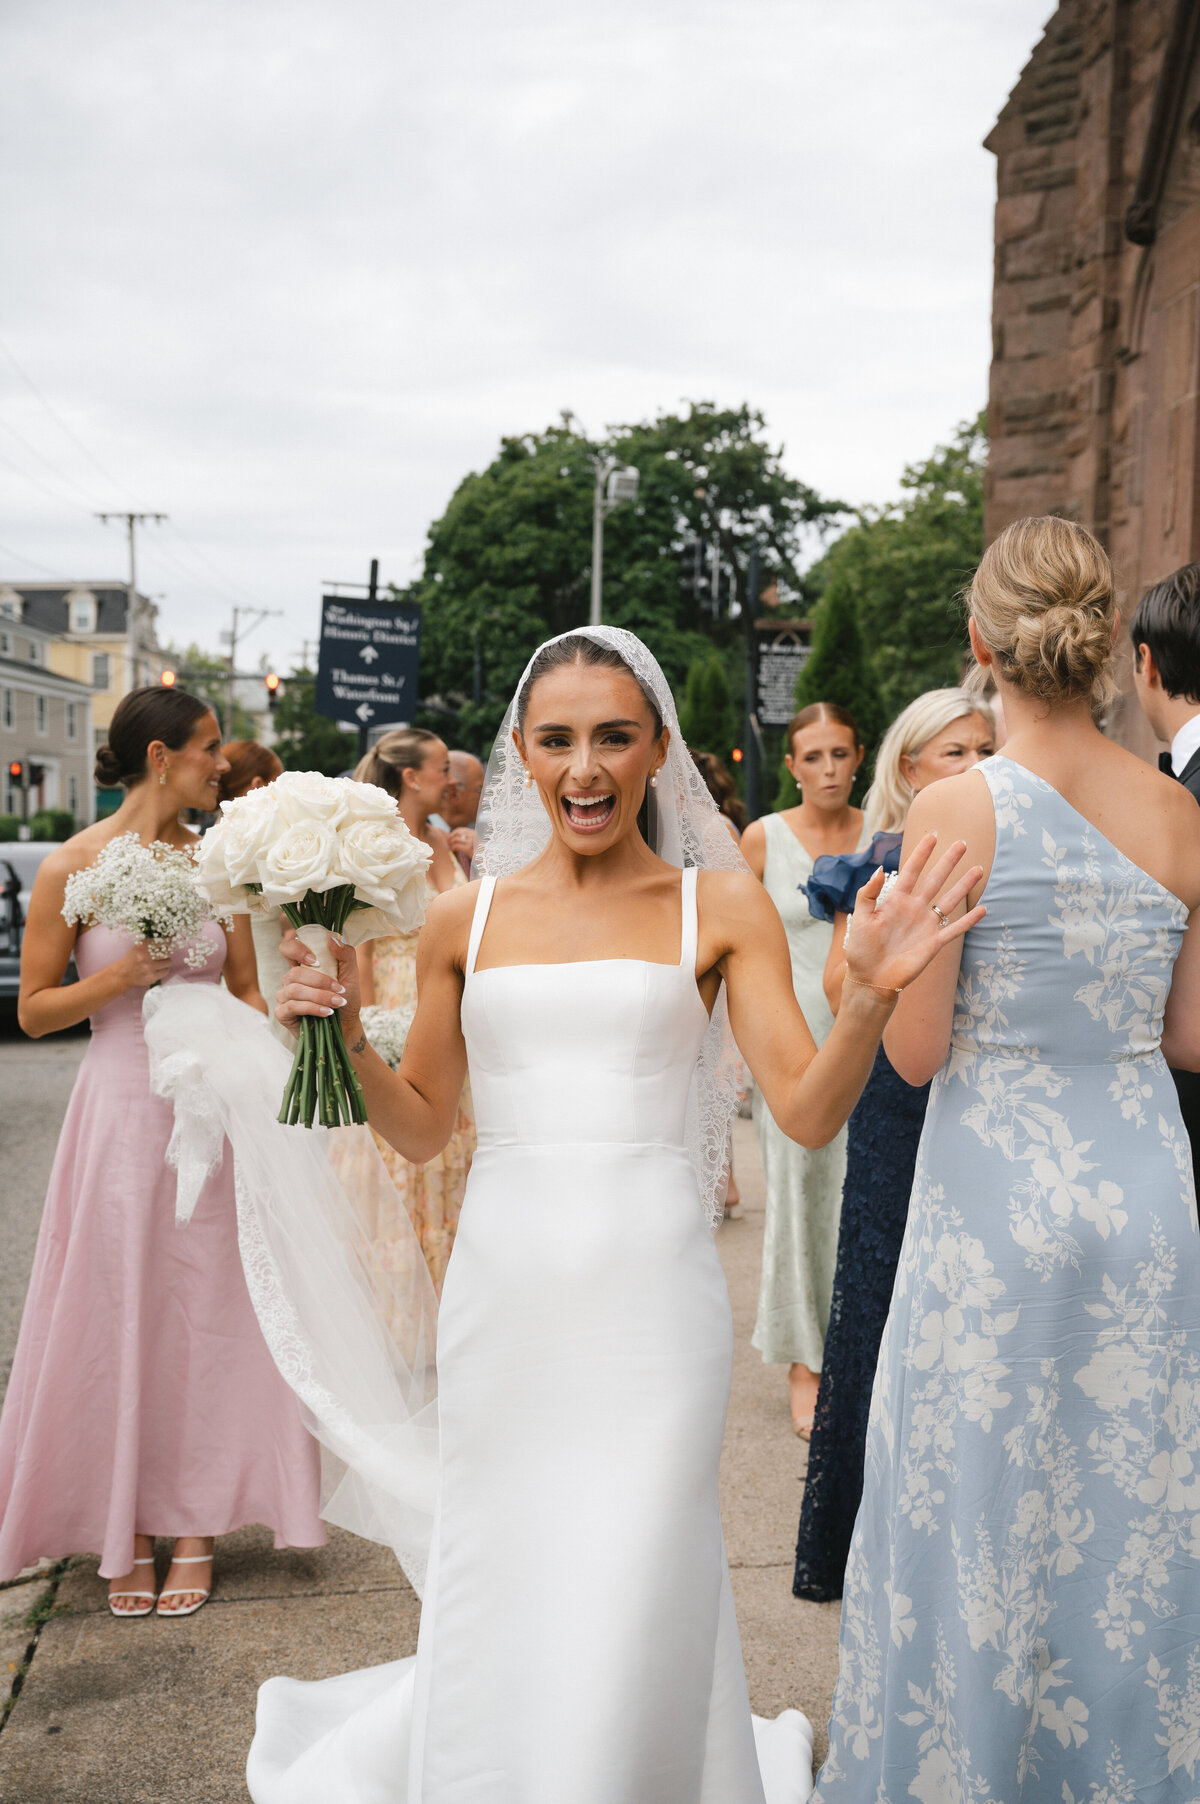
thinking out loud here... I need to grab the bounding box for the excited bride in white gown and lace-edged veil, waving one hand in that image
[249,628,982,1804]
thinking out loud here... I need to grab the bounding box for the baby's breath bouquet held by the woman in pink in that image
[63,833,231,971]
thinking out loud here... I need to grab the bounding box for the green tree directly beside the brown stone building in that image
[808,413,987,720]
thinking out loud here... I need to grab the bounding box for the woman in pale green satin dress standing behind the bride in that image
[742,702,866,1440]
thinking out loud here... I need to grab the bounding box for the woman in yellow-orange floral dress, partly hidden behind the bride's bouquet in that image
[354,727,475,1295]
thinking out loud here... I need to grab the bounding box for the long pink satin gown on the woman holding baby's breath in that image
[0,924,325,1580]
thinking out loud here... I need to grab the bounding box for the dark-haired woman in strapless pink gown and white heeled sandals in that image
[0,689,325,1616]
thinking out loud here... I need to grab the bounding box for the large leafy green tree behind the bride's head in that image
[404,402,845,750]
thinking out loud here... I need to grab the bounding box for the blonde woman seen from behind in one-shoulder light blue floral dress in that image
[816,520,1200,1804]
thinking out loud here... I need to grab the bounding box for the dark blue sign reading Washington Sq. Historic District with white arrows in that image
[316,595,420,731]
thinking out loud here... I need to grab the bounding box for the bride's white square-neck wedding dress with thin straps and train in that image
[249,870,812,1804]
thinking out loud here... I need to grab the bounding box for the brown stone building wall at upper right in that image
[985,0,1200,756]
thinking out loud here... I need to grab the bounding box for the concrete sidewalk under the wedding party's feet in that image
[0,1122,839,1804]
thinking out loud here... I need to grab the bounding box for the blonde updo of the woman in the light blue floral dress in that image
[967,516,1119,709]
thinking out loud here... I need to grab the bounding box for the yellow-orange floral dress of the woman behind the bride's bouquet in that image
[372,862,475,1297]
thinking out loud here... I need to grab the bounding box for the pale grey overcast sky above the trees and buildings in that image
[0,0,1052,666]
